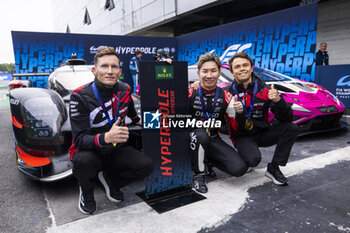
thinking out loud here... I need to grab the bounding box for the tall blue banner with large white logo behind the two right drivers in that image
[178,3,317,81]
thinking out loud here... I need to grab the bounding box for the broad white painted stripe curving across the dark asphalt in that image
[47,146,350,233]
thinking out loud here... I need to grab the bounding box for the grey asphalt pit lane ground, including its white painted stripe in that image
[0,86,350,233]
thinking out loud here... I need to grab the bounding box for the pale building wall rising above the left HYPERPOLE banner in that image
[52,0,218,35]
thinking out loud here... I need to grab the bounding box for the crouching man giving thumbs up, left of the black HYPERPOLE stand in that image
[69,47,153,214]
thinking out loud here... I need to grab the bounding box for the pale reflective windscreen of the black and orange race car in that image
[55,70,95,91]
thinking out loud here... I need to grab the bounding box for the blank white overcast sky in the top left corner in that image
[0,0,53,63]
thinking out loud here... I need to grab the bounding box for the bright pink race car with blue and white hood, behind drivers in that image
[188,64,346,136]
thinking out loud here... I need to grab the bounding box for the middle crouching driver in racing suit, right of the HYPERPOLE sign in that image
[189,53,248,193]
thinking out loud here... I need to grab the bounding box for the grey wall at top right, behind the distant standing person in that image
[317,0,350,65]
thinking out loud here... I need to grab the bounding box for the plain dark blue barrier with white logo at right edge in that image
[316,65,350,108]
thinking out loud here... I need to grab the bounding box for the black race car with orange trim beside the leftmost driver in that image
[9,59,142,182]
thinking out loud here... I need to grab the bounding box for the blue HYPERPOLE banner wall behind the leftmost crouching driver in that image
[12,31,177,87]
